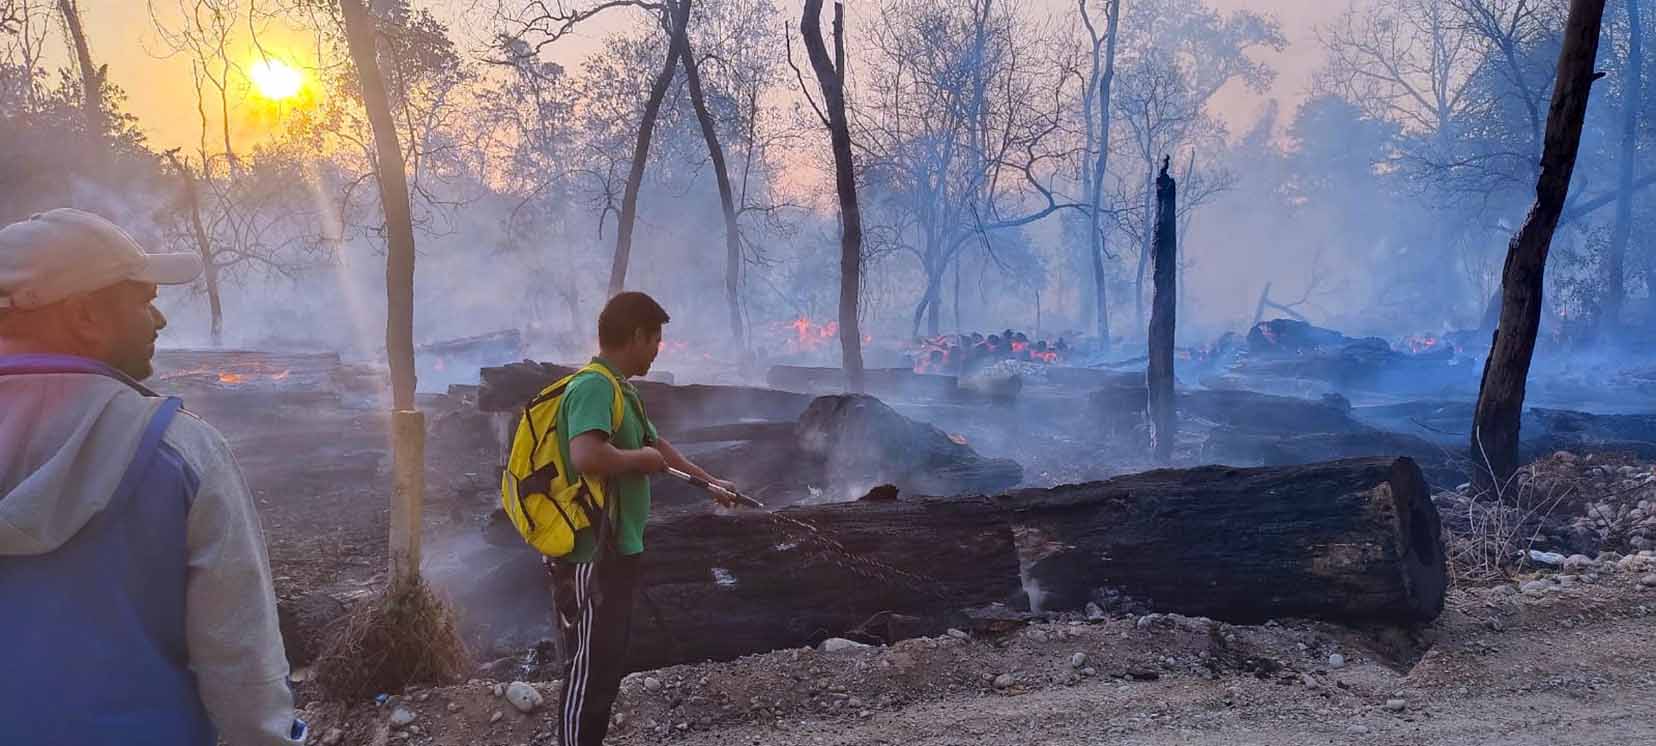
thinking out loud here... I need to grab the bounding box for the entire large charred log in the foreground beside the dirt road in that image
[433,459,1447,668]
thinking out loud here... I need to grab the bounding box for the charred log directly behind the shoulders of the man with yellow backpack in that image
[477,361,811,438]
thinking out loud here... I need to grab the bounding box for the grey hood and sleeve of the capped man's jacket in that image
[0,358,296,746]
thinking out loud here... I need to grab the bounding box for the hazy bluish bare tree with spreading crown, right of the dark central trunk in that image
[856,0,1083,333]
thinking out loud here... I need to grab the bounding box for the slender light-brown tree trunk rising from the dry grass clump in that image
[339,0,426,584]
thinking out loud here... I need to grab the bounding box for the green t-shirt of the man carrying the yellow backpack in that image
[558,358,656,562]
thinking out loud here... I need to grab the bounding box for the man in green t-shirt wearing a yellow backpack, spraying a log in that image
[502,292,734,746]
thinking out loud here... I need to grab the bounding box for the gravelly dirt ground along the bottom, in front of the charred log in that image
[306,557,1656,746]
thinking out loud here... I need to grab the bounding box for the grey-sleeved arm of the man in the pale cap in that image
[169,416,300,746]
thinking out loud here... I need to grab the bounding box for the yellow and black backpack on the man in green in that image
[500,363,626,557]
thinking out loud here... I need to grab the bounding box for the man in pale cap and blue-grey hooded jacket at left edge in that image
[0,209,305,746]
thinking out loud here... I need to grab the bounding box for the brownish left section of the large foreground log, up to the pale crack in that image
[445,497,1018,670]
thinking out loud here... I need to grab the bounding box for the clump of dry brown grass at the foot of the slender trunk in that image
[315,582,472,700]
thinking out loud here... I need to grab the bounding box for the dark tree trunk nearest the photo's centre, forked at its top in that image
[800,0,863,393]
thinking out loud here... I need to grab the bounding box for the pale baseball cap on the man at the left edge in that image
[0,207,202,310]
